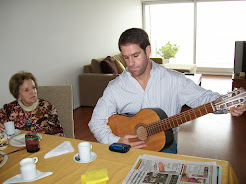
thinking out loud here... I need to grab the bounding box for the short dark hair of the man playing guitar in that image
[118,28,150,52]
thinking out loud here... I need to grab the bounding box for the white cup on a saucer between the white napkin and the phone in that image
[78,142,92,162]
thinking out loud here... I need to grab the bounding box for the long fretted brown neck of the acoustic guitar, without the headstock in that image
[147,102,214,135]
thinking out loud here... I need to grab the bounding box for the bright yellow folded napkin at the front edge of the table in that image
[81,168,109,184]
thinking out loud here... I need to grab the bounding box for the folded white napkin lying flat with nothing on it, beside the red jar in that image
[44,141,74,158]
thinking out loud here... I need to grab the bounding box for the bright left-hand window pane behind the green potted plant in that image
[145,3,194,64]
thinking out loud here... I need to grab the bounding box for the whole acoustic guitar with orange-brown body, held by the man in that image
[108,88,246,151]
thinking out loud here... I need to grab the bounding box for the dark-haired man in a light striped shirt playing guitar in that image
[89,28,246,153]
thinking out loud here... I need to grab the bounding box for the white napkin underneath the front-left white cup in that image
[3,170,53,184]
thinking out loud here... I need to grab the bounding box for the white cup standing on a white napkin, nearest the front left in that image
[20,157,38,180]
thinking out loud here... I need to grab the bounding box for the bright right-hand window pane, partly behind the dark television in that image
[196,1,246,68]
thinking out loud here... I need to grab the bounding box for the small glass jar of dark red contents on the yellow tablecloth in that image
[25,132,40,153]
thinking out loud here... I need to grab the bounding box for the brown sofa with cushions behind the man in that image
[79,54,196,107]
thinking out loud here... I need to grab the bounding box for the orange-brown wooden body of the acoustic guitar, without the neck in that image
[108,109,173,151]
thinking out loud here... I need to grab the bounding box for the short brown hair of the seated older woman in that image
[9,72,38,99]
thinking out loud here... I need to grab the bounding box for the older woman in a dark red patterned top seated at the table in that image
[0,72,64,136]
